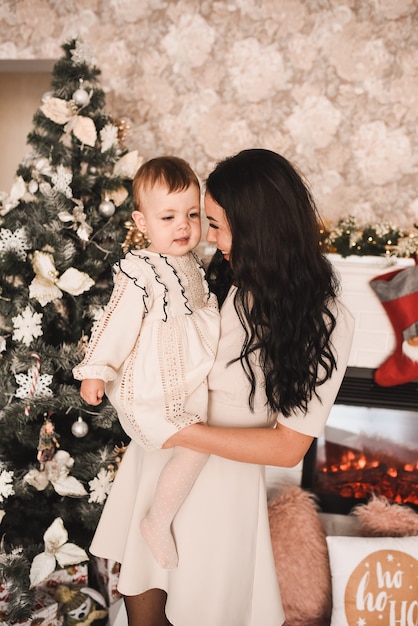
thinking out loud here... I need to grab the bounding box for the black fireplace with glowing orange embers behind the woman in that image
[302,367,418,514]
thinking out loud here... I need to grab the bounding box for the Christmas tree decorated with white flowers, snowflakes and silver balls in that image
[0,39,138,621]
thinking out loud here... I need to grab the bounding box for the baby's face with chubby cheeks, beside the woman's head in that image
[132,185,201,256]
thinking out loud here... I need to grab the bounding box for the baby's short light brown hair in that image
[132,156,200,211]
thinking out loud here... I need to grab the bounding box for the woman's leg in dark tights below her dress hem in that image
[123,589,172,626]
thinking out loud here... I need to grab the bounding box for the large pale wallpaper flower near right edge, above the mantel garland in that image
[352,121,413,185]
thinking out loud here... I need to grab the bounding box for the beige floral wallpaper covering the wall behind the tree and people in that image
[0,0,418,228]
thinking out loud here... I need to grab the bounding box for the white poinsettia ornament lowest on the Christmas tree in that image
[30,517,89,587]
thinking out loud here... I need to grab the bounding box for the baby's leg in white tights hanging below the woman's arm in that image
[141,447,209,569]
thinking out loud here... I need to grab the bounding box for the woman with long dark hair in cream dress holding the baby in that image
[92,149,353,626]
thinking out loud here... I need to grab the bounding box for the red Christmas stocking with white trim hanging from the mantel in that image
[370,265,418,387]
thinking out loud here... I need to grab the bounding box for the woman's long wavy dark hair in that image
[206,149,338,416]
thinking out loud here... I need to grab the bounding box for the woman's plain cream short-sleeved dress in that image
[91,288,353,626]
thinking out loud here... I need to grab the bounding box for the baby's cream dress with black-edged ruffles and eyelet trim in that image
[73,249,220,449]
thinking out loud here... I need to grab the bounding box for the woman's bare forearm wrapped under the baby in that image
[163,424,313,467]
